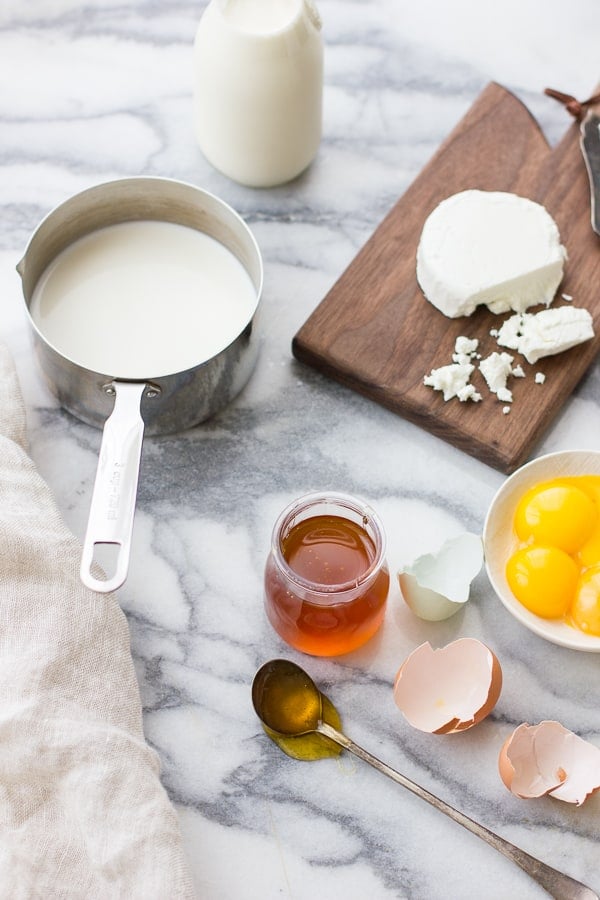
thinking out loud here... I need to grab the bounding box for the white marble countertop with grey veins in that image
[0,0,600,900]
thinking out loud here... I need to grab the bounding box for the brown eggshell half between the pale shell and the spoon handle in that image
[394,638,502,734]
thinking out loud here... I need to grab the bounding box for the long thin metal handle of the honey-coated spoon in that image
[316,722,600,900]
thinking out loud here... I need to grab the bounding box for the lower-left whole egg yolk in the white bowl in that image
[506,546,579,619]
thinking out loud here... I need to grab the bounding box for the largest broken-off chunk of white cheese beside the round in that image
[498,306,594,364]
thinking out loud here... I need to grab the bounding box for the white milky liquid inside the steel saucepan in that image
[30,221,257,379]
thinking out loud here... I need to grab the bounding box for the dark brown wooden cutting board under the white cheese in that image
[292,84,600,473]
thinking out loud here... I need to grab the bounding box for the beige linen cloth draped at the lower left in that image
[0,345,193,900]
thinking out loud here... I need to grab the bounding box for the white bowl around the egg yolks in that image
[483,450,600,653]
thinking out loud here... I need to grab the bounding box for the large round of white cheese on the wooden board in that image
[417,190,567,318]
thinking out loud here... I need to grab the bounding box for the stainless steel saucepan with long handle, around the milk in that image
[17,177,263,593]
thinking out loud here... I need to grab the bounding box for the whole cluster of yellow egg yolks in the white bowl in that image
[506,475,600,636]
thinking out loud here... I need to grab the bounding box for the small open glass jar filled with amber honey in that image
[265,493,390,656]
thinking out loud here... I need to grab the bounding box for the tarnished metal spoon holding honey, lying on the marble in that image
[252,659,600,900]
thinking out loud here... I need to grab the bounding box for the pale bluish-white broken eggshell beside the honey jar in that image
[398,532,483,622]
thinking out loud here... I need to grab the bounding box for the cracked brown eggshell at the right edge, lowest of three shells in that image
[498,721,600,806]
